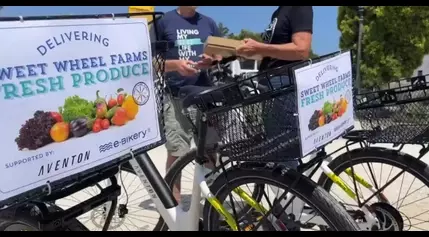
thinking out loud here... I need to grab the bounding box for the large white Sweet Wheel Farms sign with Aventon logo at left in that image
[0,18,161,200]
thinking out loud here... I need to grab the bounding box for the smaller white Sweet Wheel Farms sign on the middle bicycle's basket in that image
[295,51,354,156]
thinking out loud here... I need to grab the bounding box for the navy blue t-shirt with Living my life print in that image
[152,10,220,91]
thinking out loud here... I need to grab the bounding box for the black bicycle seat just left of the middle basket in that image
[178,85,225,108]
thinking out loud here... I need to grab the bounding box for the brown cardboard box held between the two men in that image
[204,36,262,60]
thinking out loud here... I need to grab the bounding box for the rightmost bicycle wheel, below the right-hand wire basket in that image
[318,148,429,231]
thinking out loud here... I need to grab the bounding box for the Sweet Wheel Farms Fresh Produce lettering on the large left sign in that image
[0,51,151,100]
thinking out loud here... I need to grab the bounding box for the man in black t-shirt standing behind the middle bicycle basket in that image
[237,6,313,168]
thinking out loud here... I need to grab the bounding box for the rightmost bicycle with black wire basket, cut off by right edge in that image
[318,75,429,230]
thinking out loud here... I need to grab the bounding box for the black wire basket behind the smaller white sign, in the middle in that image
[197,65,300,162]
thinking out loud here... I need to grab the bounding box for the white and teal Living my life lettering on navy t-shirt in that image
[175,29,203,60]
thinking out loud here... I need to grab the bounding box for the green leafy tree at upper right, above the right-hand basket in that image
[337,6,429,87]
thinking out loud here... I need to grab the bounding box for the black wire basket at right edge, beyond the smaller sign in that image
[355,75,429,144]
